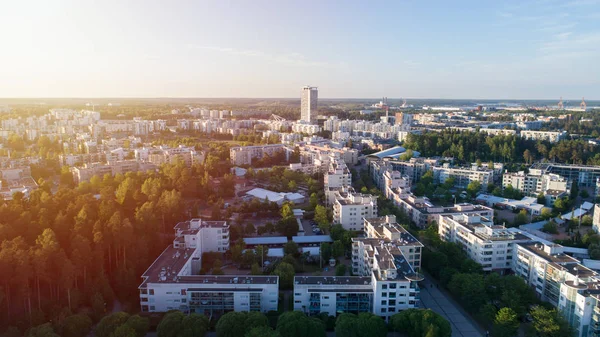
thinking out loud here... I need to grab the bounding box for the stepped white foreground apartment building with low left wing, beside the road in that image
[294,216,423,318]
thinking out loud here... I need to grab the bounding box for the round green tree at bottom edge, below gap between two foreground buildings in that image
[277,311,325,337]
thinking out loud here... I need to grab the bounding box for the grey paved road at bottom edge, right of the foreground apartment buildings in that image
[421,278,485,337]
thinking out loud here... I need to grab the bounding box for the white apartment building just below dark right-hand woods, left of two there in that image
[433,163,494,189]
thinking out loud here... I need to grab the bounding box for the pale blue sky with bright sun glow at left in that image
[0,0,600,99]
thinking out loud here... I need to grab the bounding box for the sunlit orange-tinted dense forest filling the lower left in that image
[0,157,238,332]
